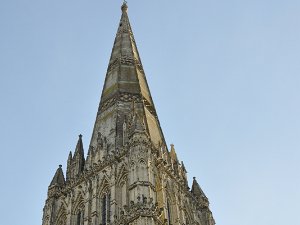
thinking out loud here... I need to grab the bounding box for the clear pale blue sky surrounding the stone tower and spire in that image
[0,0,300,225]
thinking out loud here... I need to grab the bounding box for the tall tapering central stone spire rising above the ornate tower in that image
[90,2,165,152]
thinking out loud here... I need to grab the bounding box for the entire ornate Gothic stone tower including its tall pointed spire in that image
[42,3,215,225]
